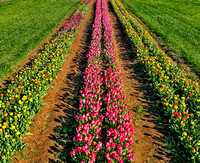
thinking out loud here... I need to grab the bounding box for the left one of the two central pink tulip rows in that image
[71,0,104,163]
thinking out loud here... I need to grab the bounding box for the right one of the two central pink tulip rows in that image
[102,0,134,163]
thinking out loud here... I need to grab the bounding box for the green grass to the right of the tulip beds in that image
[122,0,200,76]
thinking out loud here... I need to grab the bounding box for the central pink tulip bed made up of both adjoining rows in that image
[71,0,134,163]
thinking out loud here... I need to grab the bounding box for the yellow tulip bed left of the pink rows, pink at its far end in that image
[0,1,90,163]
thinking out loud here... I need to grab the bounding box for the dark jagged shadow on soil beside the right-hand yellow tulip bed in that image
[108,2,191,163]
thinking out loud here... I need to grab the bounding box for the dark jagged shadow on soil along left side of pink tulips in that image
[49,1,96,163]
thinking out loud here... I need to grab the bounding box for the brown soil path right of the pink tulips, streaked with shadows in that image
[107,0,169,163]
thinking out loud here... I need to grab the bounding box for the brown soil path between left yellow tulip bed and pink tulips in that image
[13,1,95,163]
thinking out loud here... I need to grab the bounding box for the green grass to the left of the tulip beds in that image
[0,0,82,80]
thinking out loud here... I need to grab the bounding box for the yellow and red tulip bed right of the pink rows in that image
[111,0,200,162]
